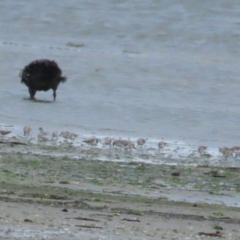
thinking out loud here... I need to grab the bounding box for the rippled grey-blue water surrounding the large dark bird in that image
[0,0,240,152]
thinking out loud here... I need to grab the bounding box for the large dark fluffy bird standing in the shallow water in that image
[19,59,67,101]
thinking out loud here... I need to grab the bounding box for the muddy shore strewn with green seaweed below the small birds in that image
[0,141,240,239]
